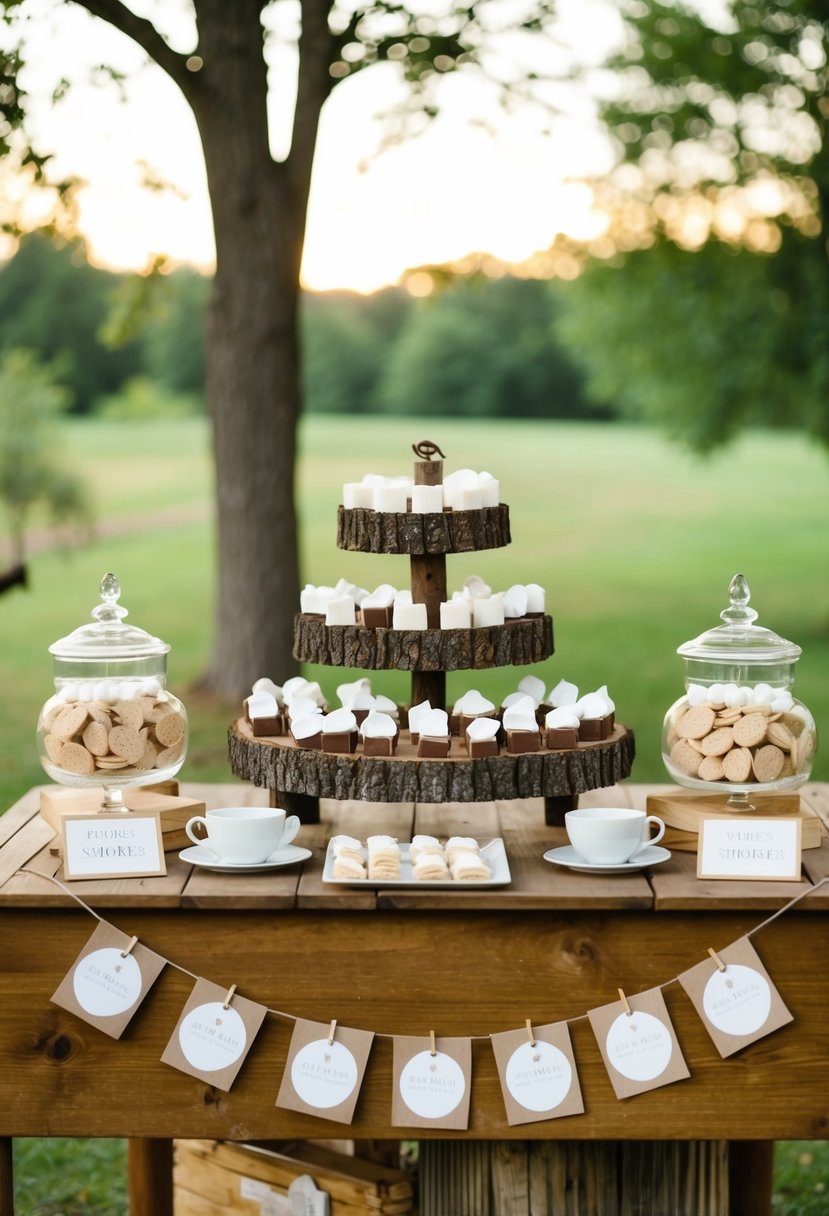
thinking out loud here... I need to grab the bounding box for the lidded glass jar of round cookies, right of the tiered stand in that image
[662,574,817,807]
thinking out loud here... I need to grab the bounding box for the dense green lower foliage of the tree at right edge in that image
[552,235,829,451]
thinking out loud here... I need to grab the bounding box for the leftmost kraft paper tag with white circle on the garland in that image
[52,921,167,1038]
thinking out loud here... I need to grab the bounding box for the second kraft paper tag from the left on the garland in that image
[162,979,267,1090]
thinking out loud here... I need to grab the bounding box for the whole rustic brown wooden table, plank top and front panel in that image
[0,784,829,1216]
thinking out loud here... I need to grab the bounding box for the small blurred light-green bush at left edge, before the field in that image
[0,350,91,563]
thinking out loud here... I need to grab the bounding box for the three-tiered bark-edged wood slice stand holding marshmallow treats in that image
[229,447,635,823]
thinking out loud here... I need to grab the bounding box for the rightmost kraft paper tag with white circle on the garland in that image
[679,938,794,1059]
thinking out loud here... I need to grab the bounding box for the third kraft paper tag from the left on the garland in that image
[276,1018,374,1124]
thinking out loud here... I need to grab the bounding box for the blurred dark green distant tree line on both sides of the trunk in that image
[0,235,598,418]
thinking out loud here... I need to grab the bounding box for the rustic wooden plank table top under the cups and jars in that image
[0,783,829,912]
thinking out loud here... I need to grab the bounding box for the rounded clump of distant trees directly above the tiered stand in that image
[382,277,597,418]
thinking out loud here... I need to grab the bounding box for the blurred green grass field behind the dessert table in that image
[0,416,829,806]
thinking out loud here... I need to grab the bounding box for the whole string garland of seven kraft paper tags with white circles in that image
[33,869,829,1131]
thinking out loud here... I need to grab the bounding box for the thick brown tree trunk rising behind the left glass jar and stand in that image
[190,0,304,698]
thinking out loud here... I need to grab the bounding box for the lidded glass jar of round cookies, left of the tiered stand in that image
[38,574,187,811]
